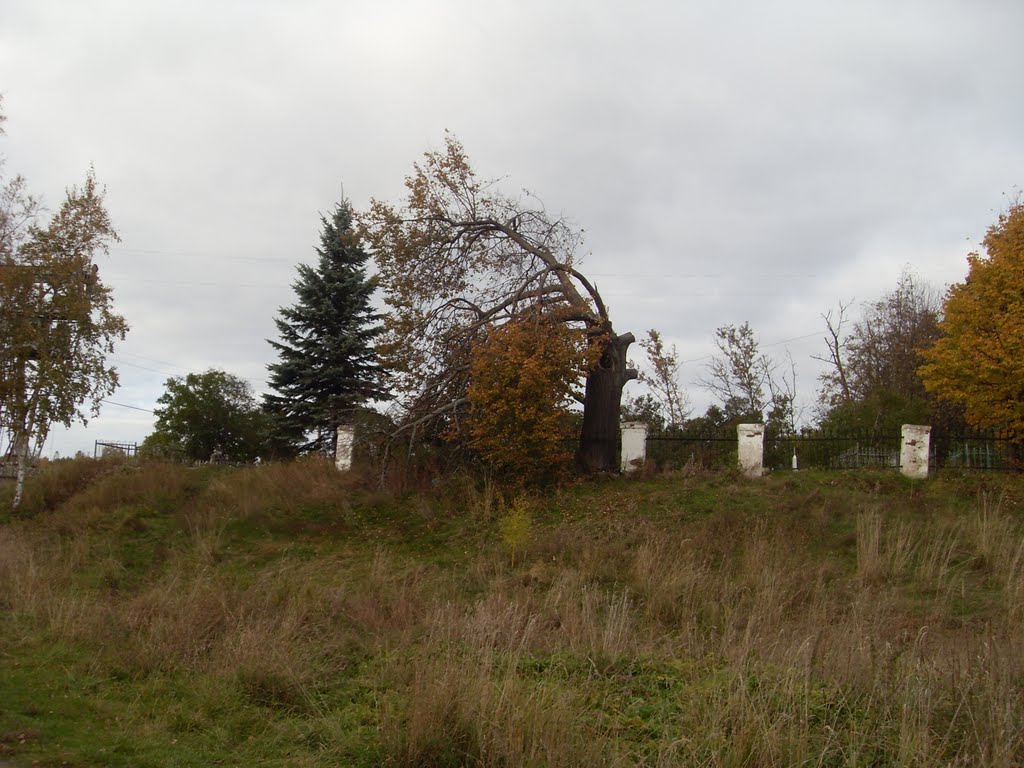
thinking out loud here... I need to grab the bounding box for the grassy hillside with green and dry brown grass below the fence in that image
[0,461,1024,767]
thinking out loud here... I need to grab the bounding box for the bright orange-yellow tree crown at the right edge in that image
[920,203,1024,441]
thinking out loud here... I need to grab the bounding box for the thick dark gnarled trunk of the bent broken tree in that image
[577,331,637,472]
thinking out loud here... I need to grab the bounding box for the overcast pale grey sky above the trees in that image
[0,0,1024,456]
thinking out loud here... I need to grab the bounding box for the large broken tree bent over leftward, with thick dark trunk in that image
[362,136,637,471]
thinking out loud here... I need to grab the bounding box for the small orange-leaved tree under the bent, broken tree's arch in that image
[468,312,592,484]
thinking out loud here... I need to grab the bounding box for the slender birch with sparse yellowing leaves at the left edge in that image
[0,102,128,508]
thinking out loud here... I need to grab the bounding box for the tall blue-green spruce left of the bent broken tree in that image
[265,201,387,453]
